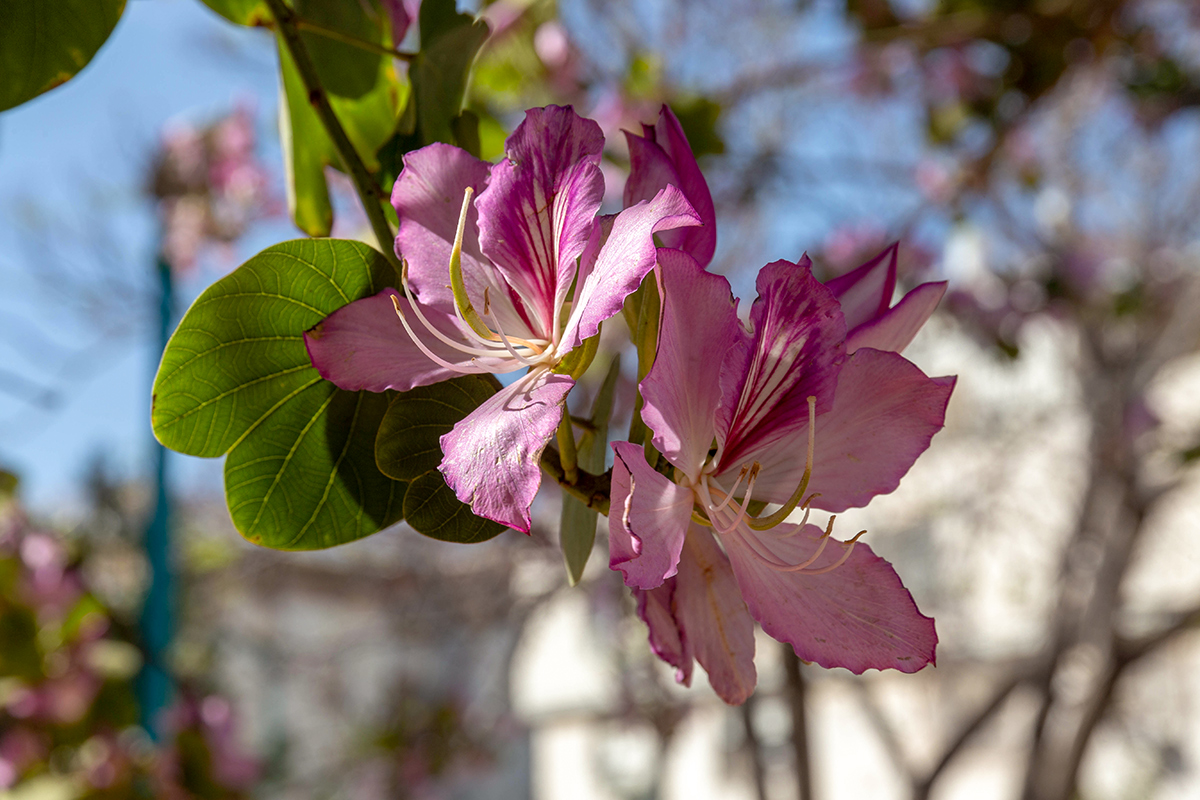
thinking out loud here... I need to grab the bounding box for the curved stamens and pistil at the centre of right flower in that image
[691,397,866,575]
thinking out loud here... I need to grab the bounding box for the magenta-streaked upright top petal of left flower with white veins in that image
[478,106,604,338]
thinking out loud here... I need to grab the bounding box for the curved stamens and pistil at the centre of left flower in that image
[391,186,557,374]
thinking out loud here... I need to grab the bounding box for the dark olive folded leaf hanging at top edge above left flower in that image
[409,0,488,150]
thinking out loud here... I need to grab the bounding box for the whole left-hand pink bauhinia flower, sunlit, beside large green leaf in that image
[305,106,700,533]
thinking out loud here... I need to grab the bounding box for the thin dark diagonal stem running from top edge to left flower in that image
[266,0,401,268]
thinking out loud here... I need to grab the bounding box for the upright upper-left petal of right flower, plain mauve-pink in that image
[641,249,749,480]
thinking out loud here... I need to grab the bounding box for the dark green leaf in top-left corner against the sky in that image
[0,0,125,112]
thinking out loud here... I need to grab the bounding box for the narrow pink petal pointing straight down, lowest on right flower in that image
[672,525,757,705]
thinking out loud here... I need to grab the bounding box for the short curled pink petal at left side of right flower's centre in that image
[608,441,694,589]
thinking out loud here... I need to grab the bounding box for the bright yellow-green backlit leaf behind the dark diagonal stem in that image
[278,32,408,236]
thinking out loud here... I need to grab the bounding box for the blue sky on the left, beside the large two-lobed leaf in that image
[0,0,295,512]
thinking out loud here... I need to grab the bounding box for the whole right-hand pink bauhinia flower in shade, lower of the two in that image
[608,249,954,703]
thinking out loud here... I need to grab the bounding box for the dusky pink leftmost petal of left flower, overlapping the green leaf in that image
[304,289,512,392]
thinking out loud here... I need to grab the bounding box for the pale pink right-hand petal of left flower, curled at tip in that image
[563,186,698,351]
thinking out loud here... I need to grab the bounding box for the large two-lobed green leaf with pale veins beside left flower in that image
[151,240,404,549]
